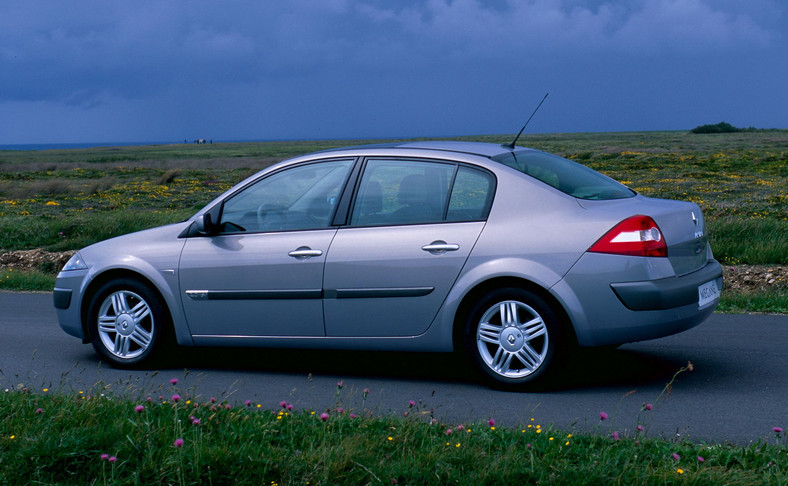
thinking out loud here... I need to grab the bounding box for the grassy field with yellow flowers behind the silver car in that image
[0,130,788,312]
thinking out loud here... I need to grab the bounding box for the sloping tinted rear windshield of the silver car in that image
[493,150,635,200]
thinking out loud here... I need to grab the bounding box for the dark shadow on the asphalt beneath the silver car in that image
[172,348,686,392]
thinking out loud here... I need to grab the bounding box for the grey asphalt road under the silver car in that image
[0,292,788,445]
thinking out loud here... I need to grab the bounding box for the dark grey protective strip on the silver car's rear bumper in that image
[610,260,722,311]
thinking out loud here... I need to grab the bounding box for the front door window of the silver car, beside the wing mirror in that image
[220,160,353,233]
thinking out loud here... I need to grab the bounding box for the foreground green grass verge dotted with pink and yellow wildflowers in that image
[0,384,788,485]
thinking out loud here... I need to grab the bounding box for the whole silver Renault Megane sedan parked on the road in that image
[54,142,722,389]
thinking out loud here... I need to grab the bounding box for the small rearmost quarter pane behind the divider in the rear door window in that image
[446,167,493,221]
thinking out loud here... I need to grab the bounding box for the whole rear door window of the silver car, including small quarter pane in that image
[350,159,493,226]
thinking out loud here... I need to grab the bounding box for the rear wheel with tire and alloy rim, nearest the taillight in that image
[464,288,566,390]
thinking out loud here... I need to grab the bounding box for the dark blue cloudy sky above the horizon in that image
[0,0,788,144]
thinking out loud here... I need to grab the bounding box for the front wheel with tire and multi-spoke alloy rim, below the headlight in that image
[88,279,172,368]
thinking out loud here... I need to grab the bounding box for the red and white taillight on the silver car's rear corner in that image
[588,215,668,257]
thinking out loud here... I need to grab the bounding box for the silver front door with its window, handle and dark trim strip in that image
[179,159,354,338]
